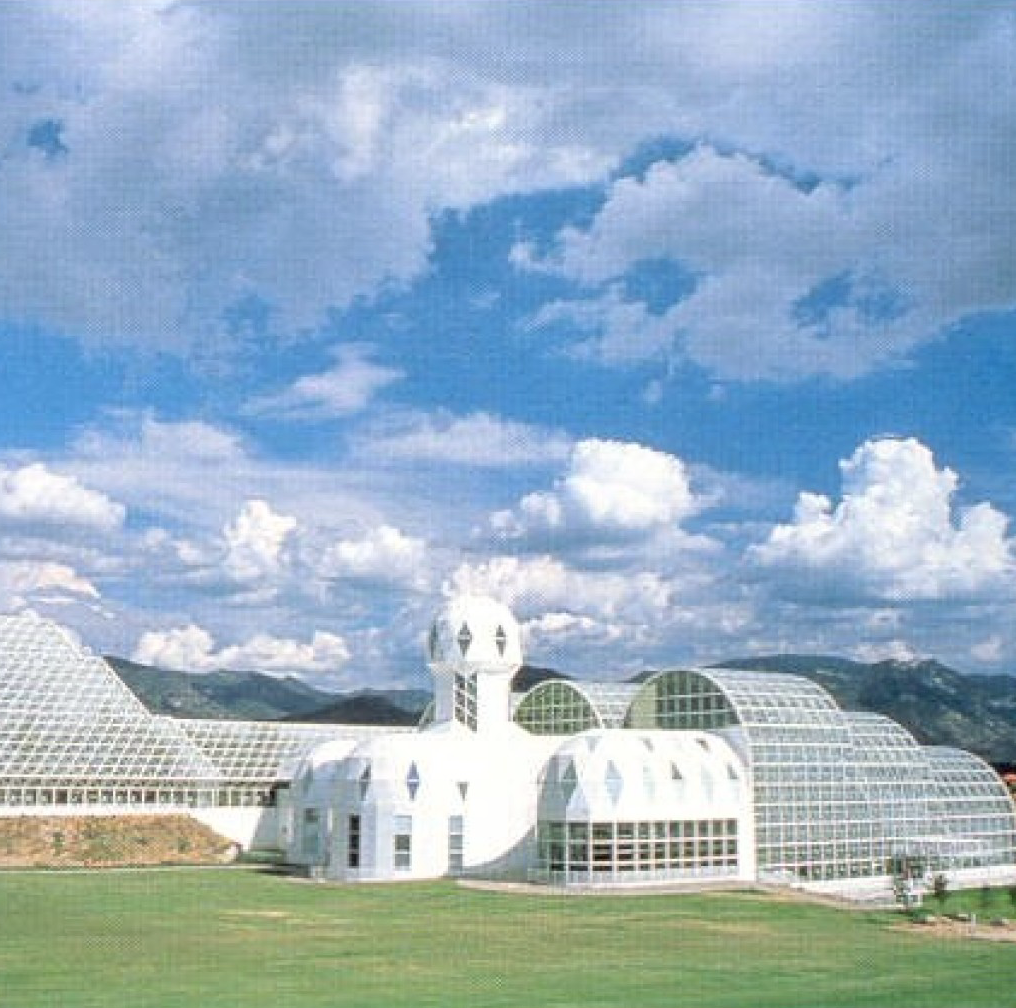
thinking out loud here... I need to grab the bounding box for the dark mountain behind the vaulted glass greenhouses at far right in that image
[720,654,1016,764]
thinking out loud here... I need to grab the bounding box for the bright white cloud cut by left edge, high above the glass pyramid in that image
[0,462,126,531]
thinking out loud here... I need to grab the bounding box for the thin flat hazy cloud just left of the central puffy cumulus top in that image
[354,412,571,468]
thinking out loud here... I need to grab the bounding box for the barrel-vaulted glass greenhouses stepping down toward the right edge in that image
[515,669,1016,883]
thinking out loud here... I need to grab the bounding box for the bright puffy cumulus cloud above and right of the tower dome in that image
[491,439,701,539]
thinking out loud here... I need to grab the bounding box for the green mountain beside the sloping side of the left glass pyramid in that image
[106,656,335,720]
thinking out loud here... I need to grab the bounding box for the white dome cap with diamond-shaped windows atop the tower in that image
[427,595,522,672]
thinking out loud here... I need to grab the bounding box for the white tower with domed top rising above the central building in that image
[427,595,522,732]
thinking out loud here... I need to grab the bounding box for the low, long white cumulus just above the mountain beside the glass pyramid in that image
[133,623,350,673]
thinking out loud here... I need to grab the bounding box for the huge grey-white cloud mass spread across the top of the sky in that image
[0,2,1016,382]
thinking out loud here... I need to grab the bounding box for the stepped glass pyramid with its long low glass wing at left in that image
[0,616,404,811]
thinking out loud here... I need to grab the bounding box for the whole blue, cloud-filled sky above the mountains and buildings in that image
[0,0,1016,689]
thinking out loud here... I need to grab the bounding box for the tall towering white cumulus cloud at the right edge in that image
[749,438,1016,603]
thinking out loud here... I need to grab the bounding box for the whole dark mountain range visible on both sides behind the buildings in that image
[107,654,1016,765]
